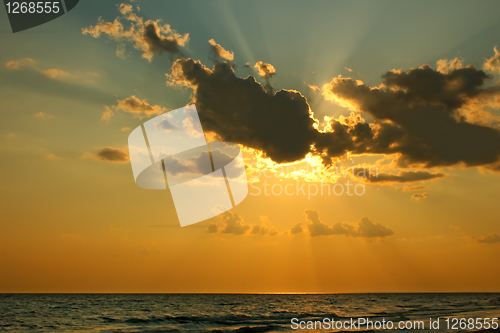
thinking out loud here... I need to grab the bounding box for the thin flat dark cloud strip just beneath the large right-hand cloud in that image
[354,168,445,183]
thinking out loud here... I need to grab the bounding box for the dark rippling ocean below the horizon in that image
[0,293,500,333]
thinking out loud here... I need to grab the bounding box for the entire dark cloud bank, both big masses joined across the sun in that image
[169,59,500,167]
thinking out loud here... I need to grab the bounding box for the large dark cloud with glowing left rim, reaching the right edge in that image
[324,65,500,167]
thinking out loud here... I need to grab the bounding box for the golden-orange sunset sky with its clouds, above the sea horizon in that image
[0,0,500,293]
